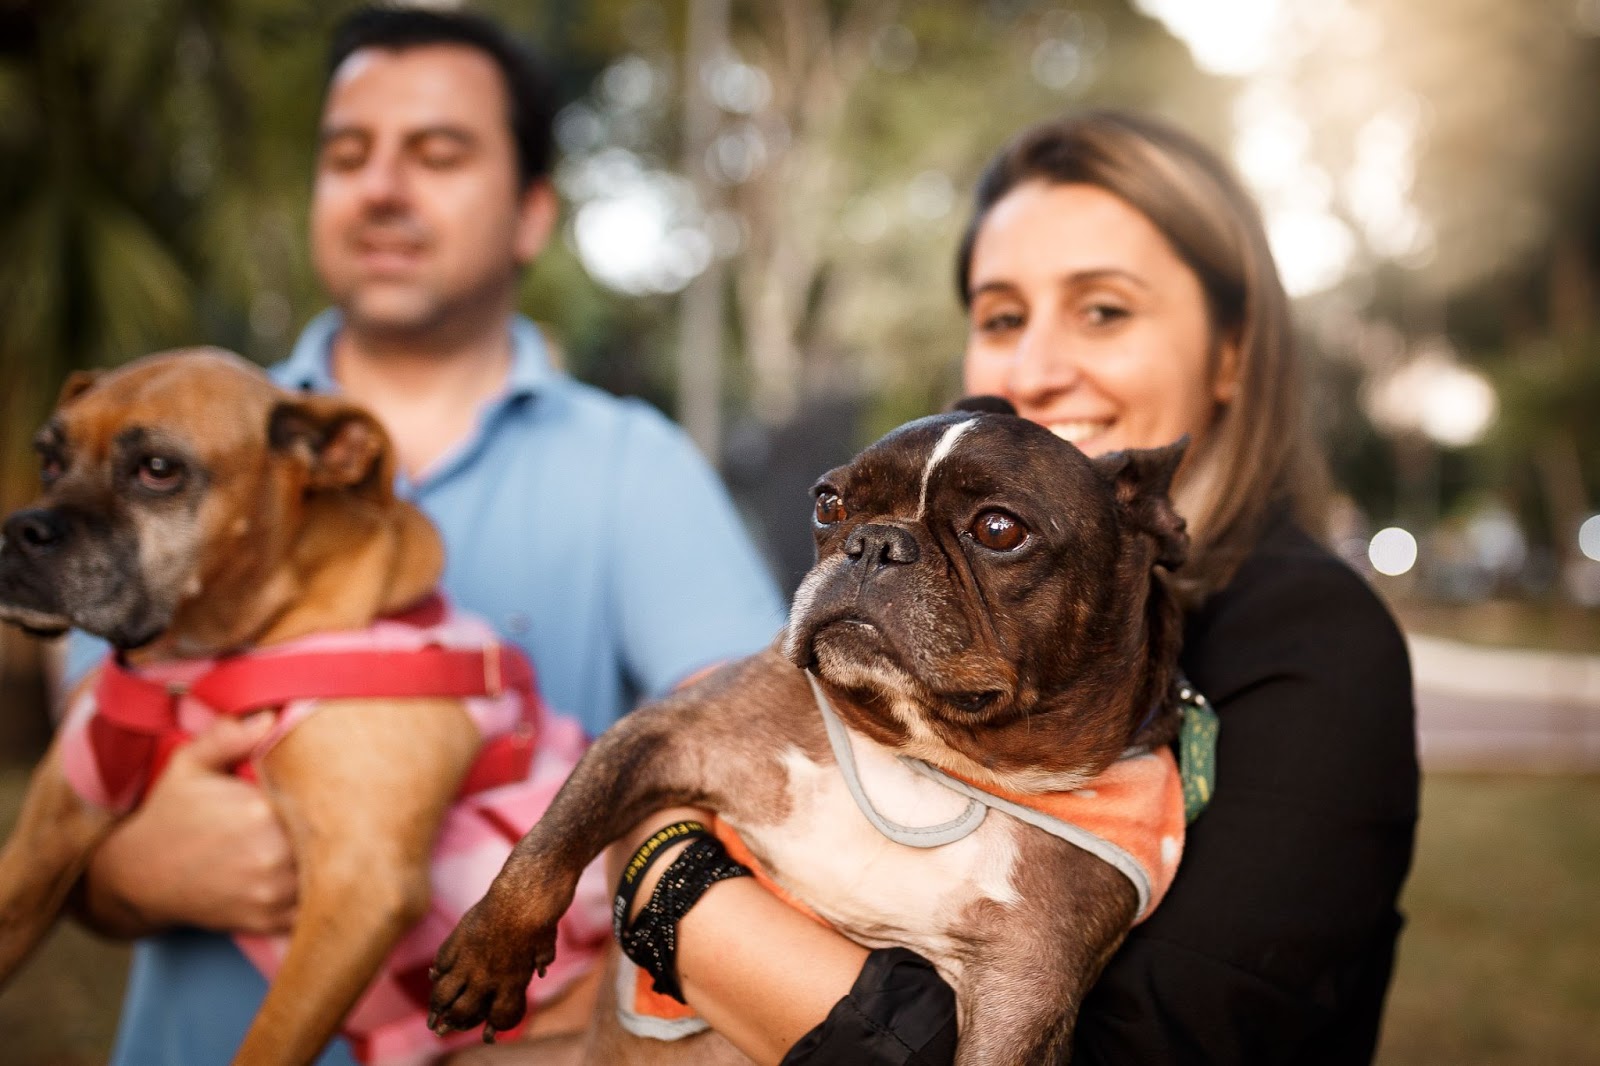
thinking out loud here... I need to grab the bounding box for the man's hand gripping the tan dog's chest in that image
[82,714,298,936]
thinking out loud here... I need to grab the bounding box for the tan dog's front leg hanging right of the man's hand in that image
[235,699,478,1066]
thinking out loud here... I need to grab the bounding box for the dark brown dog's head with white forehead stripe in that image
[784,411,1187,791]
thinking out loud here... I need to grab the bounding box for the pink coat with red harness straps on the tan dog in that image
[62,602,611,1066]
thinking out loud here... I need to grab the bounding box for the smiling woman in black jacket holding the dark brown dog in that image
[617,112,1418,1064]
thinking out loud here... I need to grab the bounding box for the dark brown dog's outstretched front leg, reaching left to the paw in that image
[430,653,800,1036]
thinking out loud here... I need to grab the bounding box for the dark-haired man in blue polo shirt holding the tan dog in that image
[74,10,782,1066]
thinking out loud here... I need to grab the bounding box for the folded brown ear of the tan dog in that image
[267,394,395,493]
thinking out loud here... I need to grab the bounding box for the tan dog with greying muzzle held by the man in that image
[0,351,478,1063]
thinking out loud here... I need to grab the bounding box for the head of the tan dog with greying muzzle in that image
[0,351,396,648]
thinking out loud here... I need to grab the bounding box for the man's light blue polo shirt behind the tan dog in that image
[100,311,782,1066]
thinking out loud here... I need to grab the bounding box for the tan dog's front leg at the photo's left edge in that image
[0,735,117,984]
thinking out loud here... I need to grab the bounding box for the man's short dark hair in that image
[328,6,555,189]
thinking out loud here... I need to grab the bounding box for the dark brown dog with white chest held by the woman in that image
[434,403,1187,1066]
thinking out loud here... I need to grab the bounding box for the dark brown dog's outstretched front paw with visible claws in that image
[427,900,555,1042]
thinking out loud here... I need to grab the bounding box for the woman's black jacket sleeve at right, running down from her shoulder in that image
[1074,520,1418,1064]
